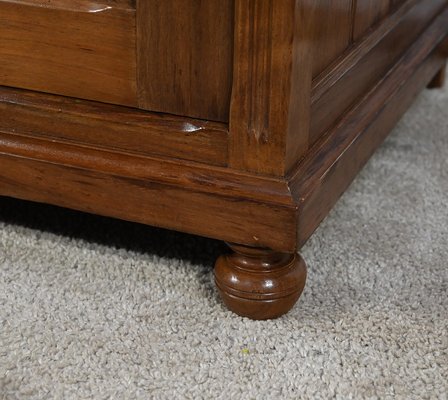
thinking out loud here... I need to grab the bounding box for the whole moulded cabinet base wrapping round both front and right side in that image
[0,3,448,252]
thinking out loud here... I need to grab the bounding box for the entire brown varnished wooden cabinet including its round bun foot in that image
[0,0,448,318]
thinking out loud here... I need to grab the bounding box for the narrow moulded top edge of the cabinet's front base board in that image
[0,130,294,208]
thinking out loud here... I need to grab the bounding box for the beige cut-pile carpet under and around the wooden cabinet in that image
[0,76,448,399]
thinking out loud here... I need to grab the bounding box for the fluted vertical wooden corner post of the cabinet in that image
[229,0,311,176]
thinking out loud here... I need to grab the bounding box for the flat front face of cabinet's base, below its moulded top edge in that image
[0,153,295,251]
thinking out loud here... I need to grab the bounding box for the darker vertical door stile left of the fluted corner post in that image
[137,0,234,122]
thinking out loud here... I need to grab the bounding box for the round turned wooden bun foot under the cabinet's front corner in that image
[215,244,306,320]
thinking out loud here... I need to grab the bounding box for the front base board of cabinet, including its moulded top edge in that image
[0,132,297,251]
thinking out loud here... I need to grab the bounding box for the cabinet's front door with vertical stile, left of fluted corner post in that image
[0,0,234,122]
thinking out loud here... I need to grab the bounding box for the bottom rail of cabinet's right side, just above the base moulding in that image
[310,0,448,144]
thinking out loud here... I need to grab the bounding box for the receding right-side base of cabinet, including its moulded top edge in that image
[289,9,448,247]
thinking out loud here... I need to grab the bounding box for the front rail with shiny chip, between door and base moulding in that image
[0,87,228,166]
